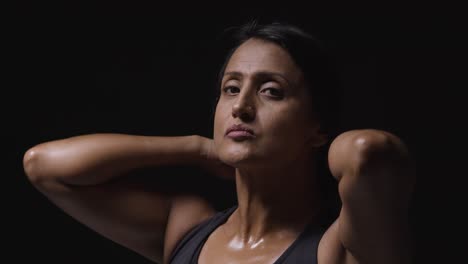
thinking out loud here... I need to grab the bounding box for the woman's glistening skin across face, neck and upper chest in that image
[200,39,325,263]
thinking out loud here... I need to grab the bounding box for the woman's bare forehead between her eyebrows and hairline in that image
[225,39,301,81]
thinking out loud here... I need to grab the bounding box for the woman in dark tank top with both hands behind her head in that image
[24,23,415,264]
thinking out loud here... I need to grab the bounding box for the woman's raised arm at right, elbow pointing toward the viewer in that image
[324,129,415,264]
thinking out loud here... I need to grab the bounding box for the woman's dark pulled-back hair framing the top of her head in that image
[216,20,342,138]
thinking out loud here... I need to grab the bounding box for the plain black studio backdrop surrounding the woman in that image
[2,4,463,263]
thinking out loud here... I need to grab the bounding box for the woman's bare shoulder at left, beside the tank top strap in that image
[164,195,216,263]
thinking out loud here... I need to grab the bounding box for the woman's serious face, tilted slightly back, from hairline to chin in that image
[214,39,324,167]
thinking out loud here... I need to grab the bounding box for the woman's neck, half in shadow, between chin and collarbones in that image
[231,156,318,243]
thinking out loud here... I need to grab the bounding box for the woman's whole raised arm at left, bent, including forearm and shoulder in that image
[24,134,232,263]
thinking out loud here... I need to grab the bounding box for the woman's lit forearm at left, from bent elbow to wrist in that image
[24,134,202,185]
